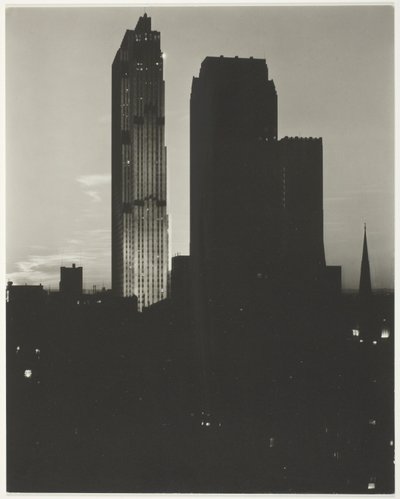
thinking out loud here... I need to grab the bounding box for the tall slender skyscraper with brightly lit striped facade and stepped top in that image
[112,14,168,310]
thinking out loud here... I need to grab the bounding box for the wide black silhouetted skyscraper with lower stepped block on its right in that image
[190,57,332,324]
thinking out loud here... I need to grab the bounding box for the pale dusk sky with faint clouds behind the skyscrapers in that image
[6,5,394,290]
